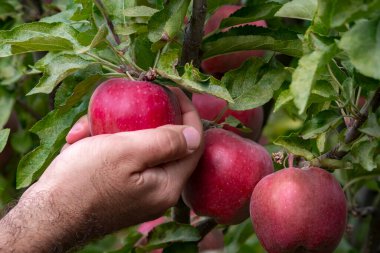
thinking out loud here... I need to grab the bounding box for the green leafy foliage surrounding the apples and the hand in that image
[0,0,380,252]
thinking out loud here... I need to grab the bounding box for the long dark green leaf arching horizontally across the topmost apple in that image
[202,26,302,59]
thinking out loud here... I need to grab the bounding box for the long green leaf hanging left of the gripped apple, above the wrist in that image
[16,103,87,189]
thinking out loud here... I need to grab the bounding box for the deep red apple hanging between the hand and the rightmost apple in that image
[183,128,273,225]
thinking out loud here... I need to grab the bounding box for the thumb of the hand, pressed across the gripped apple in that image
[115,125,201,169]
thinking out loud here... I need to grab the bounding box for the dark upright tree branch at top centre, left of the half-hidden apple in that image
[180,0,207,67]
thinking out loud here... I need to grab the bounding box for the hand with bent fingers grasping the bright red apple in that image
[0,90,202,251]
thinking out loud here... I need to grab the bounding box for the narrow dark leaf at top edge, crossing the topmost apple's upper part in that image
[220,2,281,28]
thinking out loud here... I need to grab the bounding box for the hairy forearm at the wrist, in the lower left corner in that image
[0,185,98,253]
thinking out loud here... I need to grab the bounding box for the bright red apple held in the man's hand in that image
[88,78,182,135]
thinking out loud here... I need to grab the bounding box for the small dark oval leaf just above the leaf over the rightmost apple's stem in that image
[301,110,342,139]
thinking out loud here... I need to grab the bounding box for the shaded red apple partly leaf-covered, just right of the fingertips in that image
[192,94,264,140]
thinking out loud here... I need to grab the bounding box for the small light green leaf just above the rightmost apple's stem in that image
[273,134,314,160]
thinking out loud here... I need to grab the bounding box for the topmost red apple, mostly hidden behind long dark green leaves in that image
[201,5,266,74]
